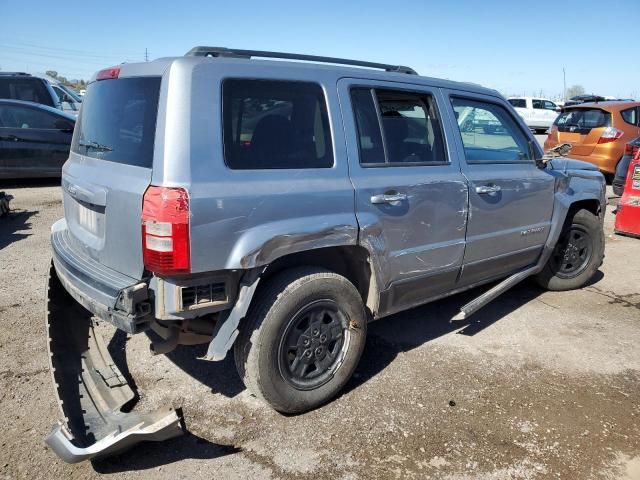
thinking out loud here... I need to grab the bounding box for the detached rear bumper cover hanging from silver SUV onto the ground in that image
[46,265,183,463]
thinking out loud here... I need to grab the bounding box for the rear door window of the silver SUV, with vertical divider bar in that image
[351,88,447,166]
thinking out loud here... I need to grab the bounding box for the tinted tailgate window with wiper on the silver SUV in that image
[71,77,160,168]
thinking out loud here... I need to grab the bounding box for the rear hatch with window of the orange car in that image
[552,107,611,156]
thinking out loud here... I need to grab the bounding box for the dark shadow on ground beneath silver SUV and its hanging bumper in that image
[93,271,604,473]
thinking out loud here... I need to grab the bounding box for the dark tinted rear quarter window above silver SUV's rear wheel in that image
[222,79,333,170]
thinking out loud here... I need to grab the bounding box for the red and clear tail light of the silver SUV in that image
[142,185,191,275]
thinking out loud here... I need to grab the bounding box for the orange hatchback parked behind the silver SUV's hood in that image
[544,101,640,177]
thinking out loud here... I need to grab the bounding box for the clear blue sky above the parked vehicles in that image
[0,0,640,98]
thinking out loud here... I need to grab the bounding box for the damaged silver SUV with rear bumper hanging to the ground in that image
[46,47,606,461]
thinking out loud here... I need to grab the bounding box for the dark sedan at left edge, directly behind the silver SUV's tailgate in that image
[0,100,75,178]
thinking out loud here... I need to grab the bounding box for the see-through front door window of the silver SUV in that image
[451,97,533,163]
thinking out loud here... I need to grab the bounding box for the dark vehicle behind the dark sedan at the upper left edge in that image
[0,71,80,115]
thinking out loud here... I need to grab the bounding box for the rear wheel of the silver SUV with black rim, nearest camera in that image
[234,268,367,413]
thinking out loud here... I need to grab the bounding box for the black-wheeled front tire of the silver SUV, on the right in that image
[535,210,604,291]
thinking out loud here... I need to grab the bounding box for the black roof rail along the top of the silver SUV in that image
[185,47,417,75]
